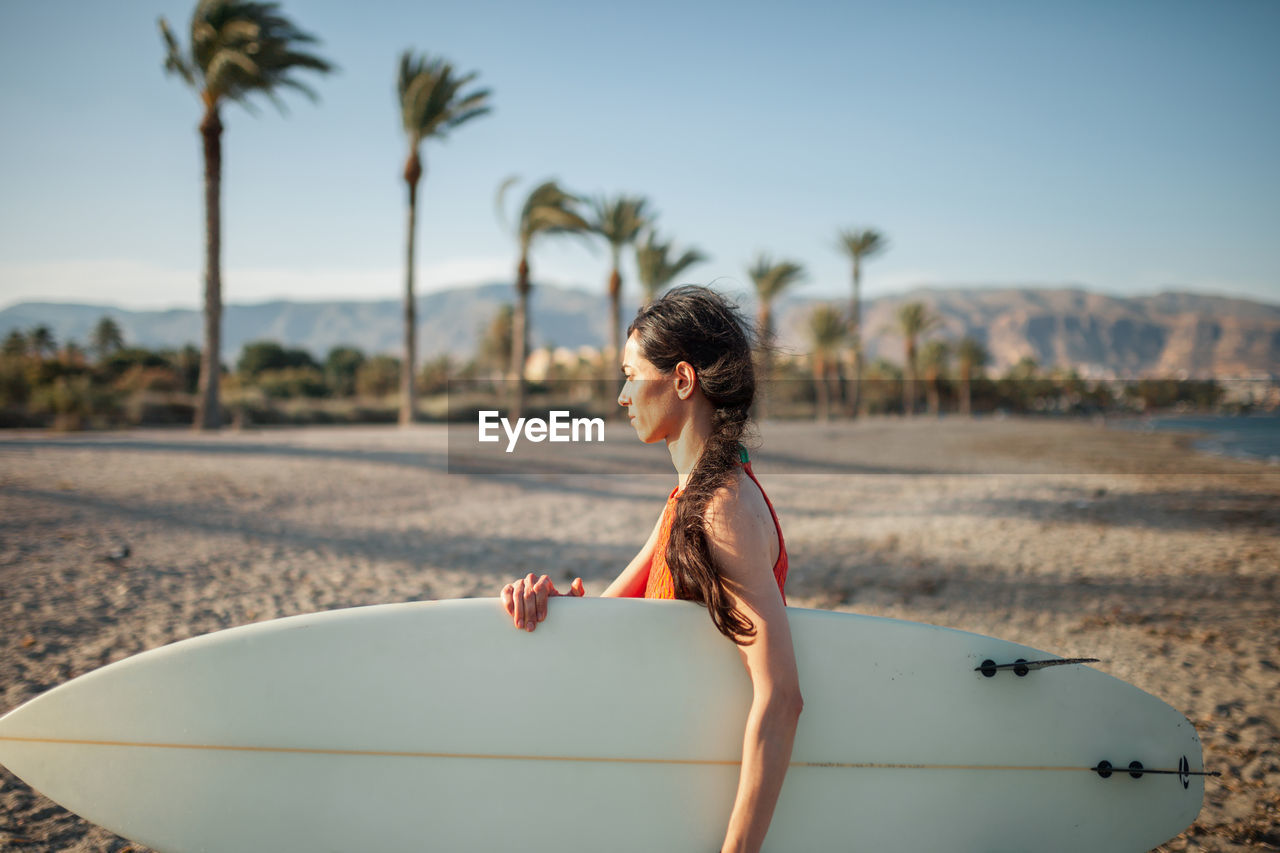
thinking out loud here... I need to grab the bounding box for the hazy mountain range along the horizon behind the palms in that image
[0,283,1280,378]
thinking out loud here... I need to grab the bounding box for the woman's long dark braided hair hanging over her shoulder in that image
[627,284,755,646]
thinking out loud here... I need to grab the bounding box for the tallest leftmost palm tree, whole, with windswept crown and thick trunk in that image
[159,0,333,429]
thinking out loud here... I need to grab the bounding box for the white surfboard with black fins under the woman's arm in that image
[0,599,1203,853]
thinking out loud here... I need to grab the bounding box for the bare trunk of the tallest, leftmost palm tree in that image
[195,105,223,429]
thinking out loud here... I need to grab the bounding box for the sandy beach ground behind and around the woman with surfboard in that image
[0,419,1280,853]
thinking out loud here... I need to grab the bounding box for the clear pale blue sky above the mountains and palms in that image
[0,0,1280,306]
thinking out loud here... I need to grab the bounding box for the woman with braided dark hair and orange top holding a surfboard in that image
[502,286,803,853]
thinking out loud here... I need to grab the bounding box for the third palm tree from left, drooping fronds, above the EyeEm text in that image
[498,178,590,418]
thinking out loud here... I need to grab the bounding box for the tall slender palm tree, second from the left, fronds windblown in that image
[396,50,490,427]
